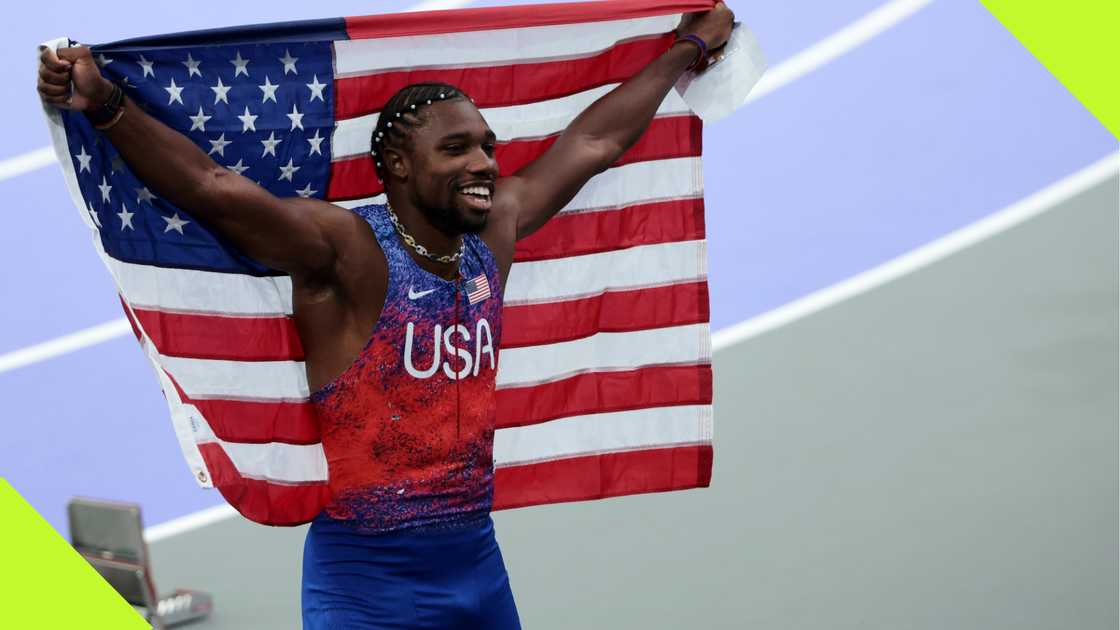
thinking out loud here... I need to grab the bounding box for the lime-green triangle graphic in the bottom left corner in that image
[0,478,151,630]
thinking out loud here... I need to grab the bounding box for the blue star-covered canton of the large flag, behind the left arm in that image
[63,41,334,276]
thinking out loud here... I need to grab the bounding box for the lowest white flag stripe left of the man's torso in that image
[210,441,327,483]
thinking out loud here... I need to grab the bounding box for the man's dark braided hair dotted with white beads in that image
[370,83,470,182]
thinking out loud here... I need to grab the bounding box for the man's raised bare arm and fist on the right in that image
[495,2,735,240]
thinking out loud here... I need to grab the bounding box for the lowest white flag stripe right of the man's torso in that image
[494,405,711,466]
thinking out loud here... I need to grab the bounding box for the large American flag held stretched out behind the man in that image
[41,0,761,525]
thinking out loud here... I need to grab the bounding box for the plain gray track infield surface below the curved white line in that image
[144,178,1120,630]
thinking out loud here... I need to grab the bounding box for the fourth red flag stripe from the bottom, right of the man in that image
[513,198,704,262]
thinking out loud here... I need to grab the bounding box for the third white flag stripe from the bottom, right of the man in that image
[505,241,707,305]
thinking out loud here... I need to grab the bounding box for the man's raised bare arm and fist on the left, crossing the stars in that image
[38,47,360,277]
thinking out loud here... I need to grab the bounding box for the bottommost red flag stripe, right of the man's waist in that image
[494,445,712,510]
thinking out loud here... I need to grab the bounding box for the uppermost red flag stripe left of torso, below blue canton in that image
[133,308,304,361]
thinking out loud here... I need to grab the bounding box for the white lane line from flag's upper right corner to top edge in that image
[747,0,933,103]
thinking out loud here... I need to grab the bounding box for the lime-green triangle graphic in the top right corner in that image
[981,0,1120,138]
